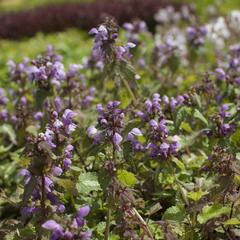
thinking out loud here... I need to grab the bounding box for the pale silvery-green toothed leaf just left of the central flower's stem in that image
[76,172,101,194]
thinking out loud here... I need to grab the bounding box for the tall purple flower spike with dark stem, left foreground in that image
[20,109,76,221]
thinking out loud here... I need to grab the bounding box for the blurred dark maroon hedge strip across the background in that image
[0,0,181,39]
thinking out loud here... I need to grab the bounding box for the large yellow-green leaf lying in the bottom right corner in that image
[197,204,231,224]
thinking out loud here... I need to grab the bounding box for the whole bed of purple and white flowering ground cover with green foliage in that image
[0,2,240,240]
